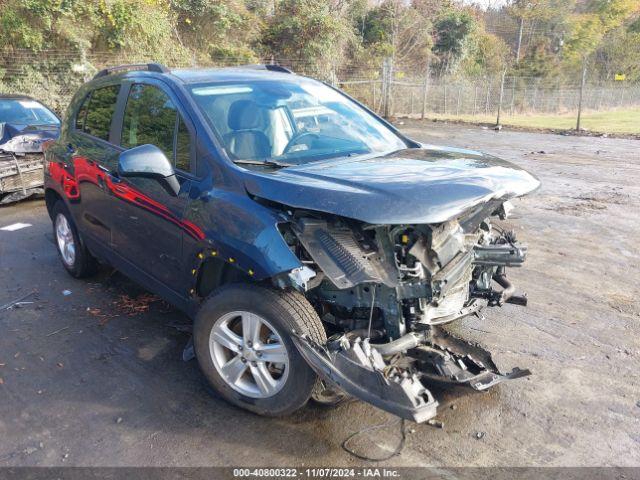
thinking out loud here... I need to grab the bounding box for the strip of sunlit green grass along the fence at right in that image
[429,108,640,134]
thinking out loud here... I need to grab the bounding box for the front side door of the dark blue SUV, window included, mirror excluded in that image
[110,82,194,295]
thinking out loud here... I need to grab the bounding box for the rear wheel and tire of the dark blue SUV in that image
[51,200,98,278]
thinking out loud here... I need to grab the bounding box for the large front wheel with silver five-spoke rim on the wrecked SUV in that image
[193,284,326,416]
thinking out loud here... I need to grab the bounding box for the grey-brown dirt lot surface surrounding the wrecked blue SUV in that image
[0,123,640,466]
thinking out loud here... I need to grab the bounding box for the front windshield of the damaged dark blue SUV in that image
[191,78,406,164]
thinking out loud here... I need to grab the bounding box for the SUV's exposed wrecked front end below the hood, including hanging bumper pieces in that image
[282,201,530,422]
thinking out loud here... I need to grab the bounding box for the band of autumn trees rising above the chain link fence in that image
[0,0,640,80]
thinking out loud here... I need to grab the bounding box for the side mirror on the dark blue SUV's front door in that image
[118,145,180,196]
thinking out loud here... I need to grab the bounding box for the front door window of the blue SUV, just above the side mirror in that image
[121,84,191,172]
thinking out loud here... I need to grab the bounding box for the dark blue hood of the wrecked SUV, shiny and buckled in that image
[245,145,540,225]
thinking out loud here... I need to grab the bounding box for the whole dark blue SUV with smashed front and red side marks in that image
[46,64,539,422]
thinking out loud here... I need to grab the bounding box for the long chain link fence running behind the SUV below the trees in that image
[0,50,640,133]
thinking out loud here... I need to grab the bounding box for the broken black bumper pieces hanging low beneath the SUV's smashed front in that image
[292,327,531,423]
